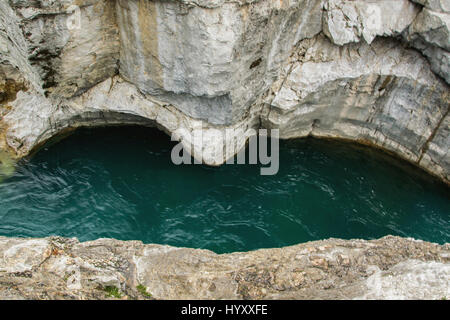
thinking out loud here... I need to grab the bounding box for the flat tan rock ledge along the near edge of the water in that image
[0,237,450,299]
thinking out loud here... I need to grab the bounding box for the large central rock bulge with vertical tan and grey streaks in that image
[117,0,322,124]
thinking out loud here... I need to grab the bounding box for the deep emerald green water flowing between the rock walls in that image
[0,127,450,253]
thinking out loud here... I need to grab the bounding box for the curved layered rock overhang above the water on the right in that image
[264,37,450,180]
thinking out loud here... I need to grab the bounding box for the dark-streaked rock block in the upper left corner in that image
[0,0,120,97]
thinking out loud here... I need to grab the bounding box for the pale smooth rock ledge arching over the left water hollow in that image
[4,76,259,165]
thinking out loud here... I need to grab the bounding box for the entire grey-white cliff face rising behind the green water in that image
[0,0,450,182]
